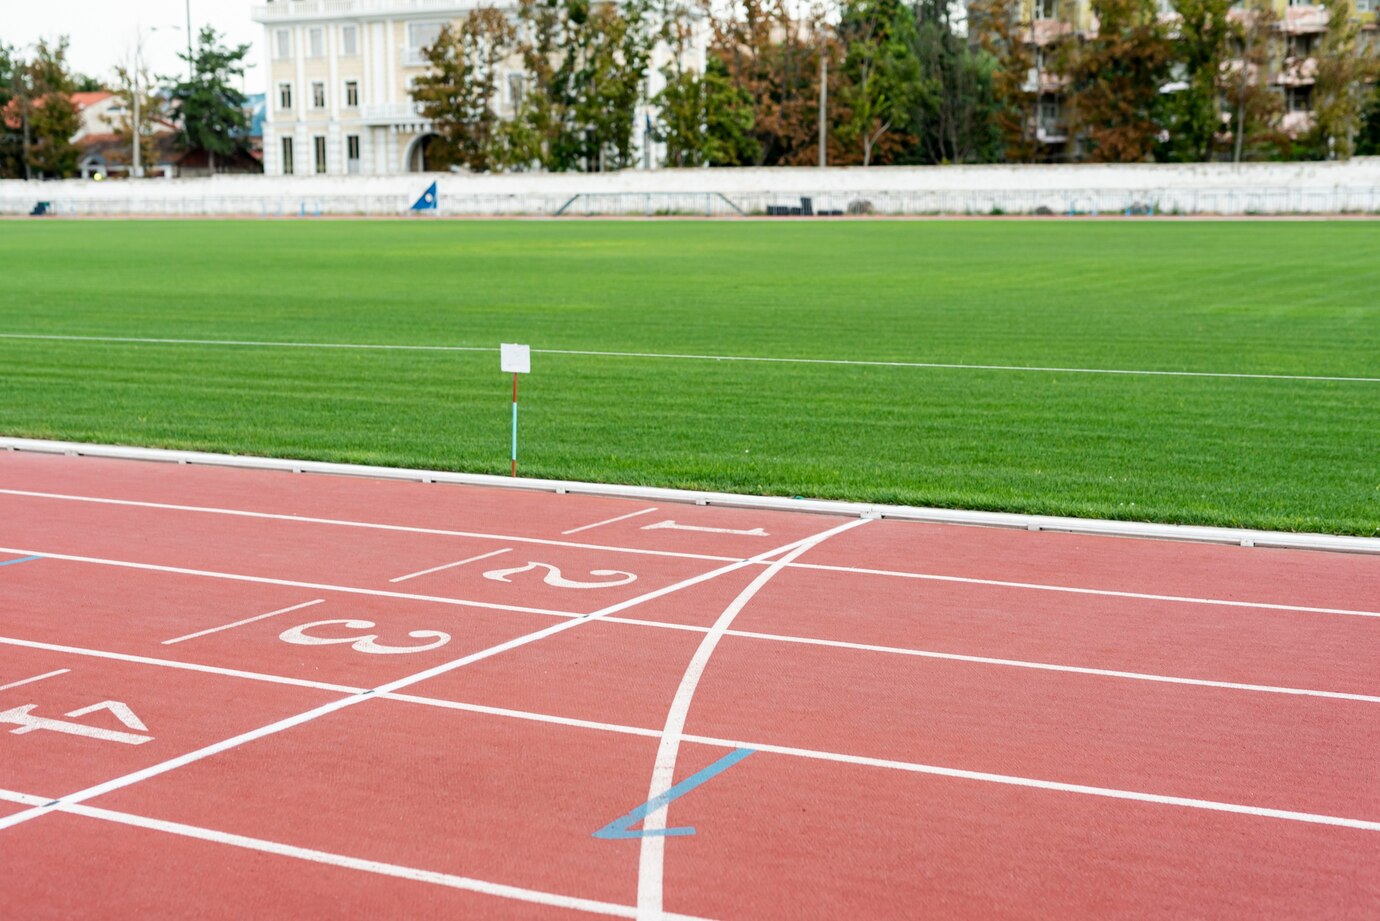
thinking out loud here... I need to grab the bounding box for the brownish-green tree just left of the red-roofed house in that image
[18,36,81,178]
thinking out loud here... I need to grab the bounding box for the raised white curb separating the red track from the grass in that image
[0,438,1380,559]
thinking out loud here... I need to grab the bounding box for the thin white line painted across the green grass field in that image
[0,333,1380,384]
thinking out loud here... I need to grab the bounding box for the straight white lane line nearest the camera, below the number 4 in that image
[0,790,701,918]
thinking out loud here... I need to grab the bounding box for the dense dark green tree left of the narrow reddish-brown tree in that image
[907,0,1001,163]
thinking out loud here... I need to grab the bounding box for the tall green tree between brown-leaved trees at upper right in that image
[1163,0,1236,163]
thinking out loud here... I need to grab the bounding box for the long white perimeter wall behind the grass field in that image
[0,157,1380,217]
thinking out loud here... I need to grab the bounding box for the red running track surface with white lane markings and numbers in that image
[0,453,1380,918]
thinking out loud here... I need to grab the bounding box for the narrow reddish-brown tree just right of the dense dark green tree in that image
[967,0,1041,163]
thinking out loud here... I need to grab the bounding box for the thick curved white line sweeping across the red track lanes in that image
[638,518,871,921]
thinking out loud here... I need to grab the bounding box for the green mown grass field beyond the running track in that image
[0,221,1380,534]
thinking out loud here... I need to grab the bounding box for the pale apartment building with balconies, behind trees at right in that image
[1021,0,1380,159]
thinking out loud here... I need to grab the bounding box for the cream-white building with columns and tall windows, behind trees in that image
[254,0,705,175]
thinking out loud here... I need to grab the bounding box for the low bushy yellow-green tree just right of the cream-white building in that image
[654,58,760,166]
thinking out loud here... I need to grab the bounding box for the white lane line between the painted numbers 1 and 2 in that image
[0,489,1380,617]
